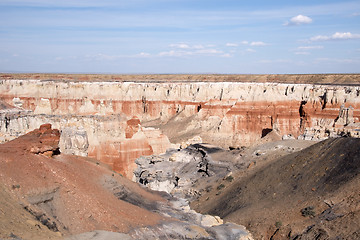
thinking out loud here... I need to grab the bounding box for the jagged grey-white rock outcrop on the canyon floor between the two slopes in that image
[134,144,233,199]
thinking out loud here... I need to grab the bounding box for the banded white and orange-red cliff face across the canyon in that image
[0,80,360,177]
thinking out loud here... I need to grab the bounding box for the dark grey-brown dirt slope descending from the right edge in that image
[192,138,360,239]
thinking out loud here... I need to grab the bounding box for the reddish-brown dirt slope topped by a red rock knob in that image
[0,125,165,239]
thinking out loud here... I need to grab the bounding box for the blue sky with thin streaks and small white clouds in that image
[0,0,360,74]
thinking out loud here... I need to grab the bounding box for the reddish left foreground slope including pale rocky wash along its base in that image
[0,124,252,240]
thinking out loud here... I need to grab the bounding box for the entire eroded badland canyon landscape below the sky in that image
[0,74,360,240]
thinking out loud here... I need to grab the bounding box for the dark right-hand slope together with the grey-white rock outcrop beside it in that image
[135,135,360,240]
